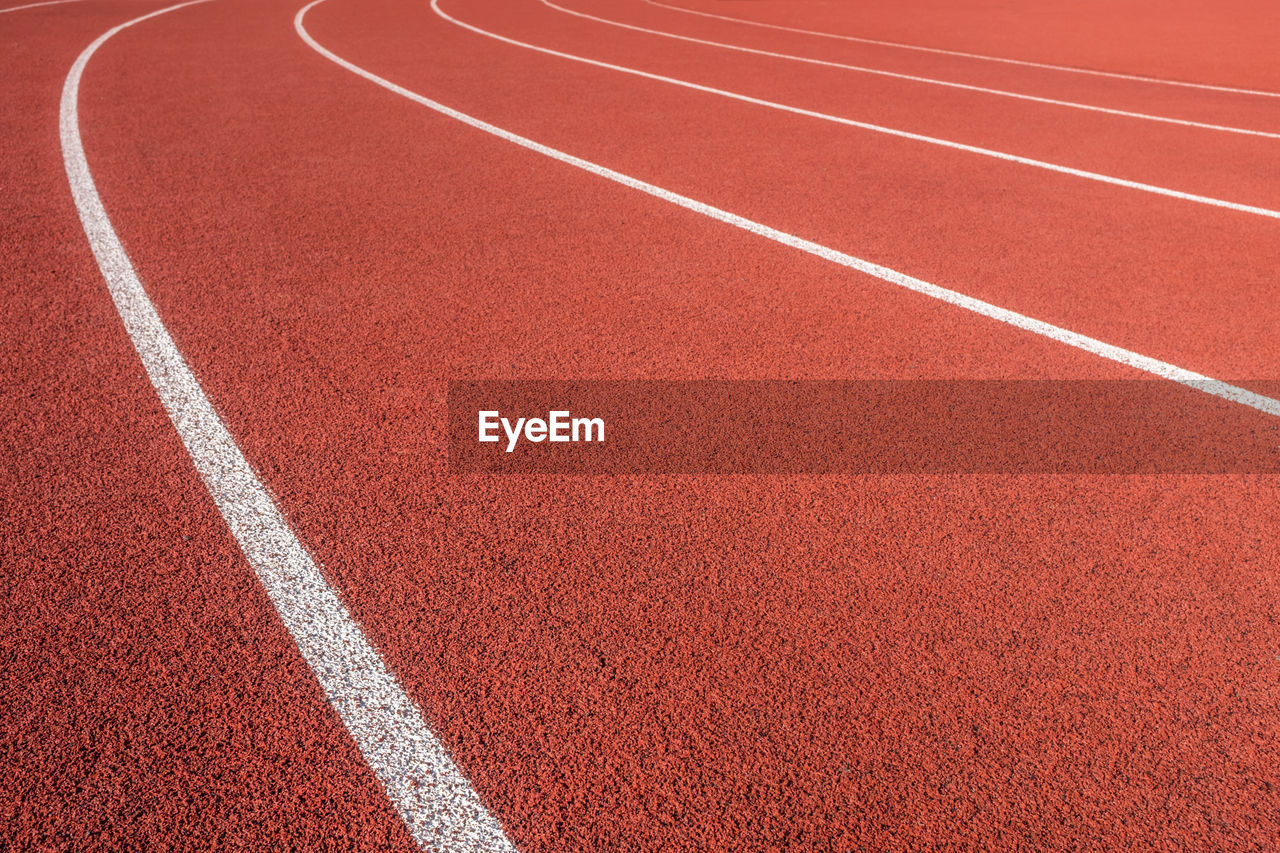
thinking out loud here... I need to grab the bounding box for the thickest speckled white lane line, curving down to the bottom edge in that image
[60,6,515,853]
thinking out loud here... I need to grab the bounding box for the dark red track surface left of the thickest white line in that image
[0,0,412,849]
